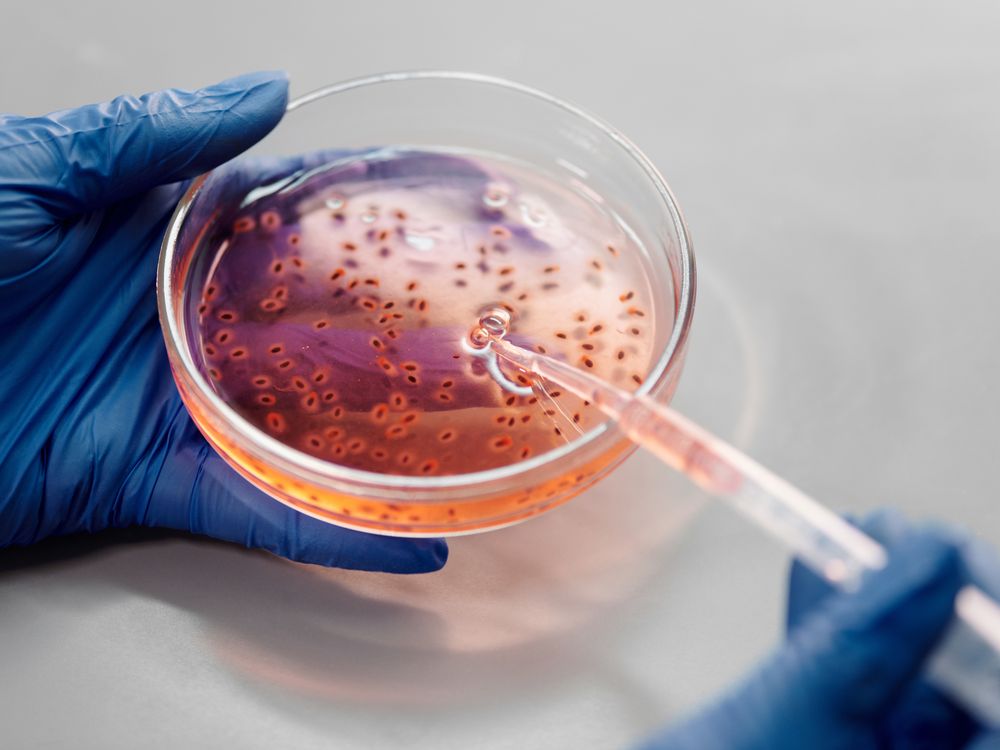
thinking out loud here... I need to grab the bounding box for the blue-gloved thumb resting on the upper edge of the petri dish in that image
[0,72,288,280]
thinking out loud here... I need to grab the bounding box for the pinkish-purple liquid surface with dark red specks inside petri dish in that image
[189,150,670,475]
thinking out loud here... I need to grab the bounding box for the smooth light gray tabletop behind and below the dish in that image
[0,0,1000,749]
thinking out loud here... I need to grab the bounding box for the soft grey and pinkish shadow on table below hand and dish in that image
[0,457,697,710]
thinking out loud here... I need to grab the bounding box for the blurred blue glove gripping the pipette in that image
[644,512,1000,750]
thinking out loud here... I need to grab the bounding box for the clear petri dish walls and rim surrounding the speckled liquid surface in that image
[157,71,695,536]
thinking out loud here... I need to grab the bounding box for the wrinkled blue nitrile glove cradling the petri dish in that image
[0,73,447,573]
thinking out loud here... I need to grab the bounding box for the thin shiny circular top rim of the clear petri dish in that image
[156,70,696,492]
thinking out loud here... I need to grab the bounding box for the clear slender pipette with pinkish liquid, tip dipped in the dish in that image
[470,313,1000,728]
